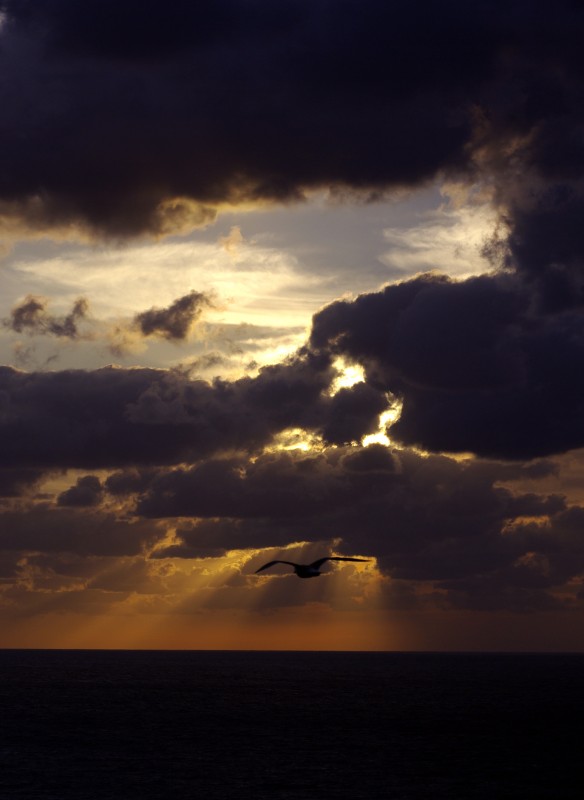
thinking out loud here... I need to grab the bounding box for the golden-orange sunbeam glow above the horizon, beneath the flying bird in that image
[28,543,387,650]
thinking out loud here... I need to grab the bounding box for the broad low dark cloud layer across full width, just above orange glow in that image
[0,428,584,612]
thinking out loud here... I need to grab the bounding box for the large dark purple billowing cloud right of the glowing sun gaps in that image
[311,274,584,459]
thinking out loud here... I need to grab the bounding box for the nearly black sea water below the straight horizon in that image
[0,650,584,800]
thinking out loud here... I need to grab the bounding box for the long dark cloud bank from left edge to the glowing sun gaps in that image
[0,353,385,469]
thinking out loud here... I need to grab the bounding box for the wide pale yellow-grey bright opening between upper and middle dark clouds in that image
[0,186,496,378]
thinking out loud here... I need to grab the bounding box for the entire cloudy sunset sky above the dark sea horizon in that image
[0,0,584,651]
